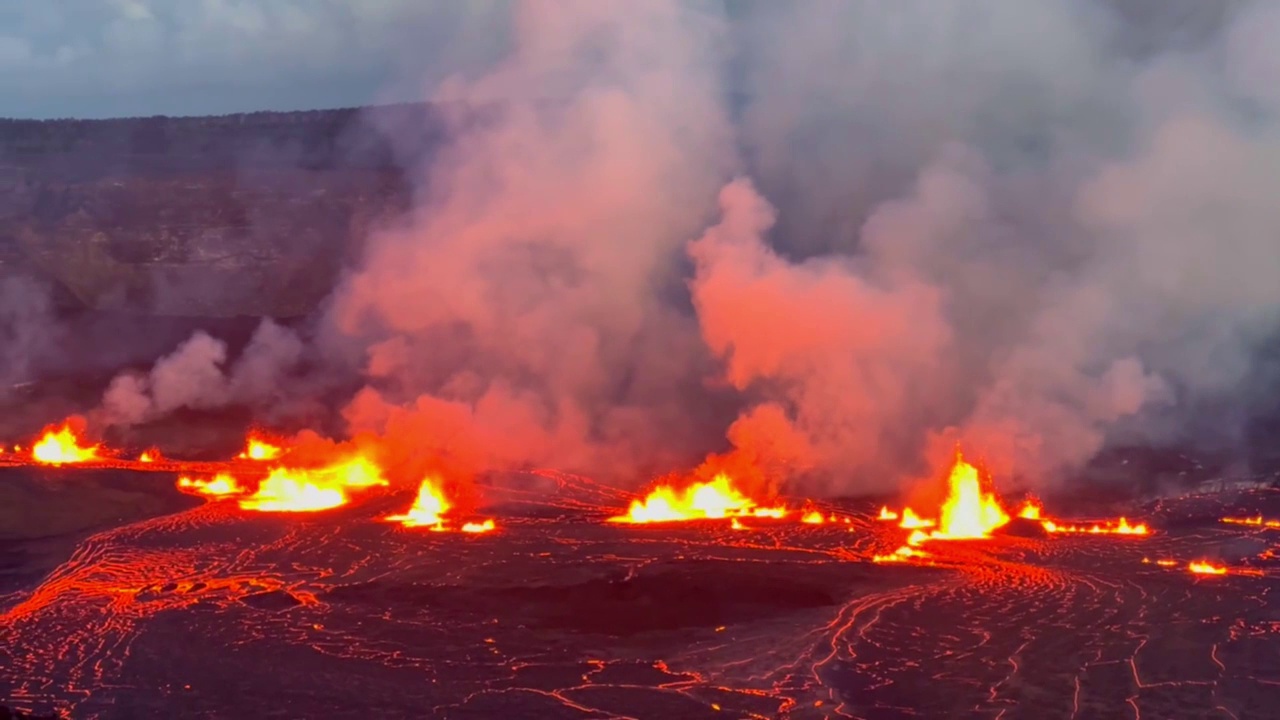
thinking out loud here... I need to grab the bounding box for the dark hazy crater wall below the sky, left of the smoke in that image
[0,105,439,318]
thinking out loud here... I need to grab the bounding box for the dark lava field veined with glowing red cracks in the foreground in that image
[0,468,1280,719]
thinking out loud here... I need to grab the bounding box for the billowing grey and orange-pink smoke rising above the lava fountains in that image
[77,0,1280,493]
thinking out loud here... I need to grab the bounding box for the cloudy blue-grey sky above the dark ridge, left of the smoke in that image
[0,0,508,118]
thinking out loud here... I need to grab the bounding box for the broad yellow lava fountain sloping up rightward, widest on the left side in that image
[239,456,387,512]
